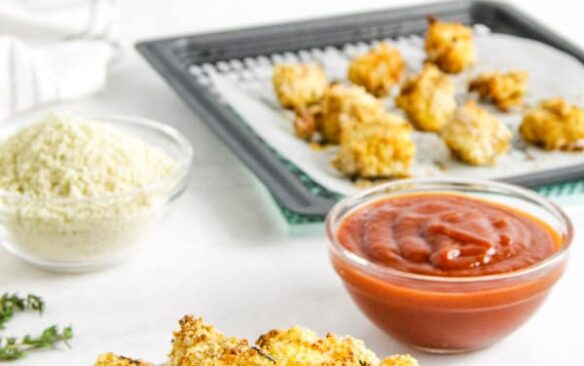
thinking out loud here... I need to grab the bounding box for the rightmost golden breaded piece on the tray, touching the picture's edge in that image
[519,98,584,151]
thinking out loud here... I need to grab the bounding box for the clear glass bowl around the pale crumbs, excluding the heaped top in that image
[0,114,193,272]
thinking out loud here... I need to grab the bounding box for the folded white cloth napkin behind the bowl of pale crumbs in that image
[0,0,117,118]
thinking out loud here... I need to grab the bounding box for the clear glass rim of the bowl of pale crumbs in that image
[0,111,193,204]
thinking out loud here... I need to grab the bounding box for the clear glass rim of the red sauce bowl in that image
[325,178,574,283]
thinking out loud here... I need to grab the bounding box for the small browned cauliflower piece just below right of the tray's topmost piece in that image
[468,70,528,112]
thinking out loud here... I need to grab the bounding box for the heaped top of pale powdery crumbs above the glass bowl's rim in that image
[0,114,175,198]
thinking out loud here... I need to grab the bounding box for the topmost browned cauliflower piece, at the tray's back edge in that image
[425,17,476,74]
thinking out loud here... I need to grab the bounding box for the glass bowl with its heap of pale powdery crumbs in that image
[0,113,192,272]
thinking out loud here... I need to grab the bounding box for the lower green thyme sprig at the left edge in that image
[0,325,73,361]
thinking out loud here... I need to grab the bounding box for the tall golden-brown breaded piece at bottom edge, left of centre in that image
[167,316,274,366]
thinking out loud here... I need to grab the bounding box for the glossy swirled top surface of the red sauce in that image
[338,194,560,276]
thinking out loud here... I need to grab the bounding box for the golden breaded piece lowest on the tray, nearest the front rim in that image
[333,113,416,178]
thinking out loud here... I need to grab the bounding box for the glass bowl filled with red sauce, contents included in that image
[326,179,573,353]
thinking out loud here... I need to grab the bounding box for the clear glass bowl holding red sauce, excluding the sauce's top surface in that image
[326,179,573,353]
